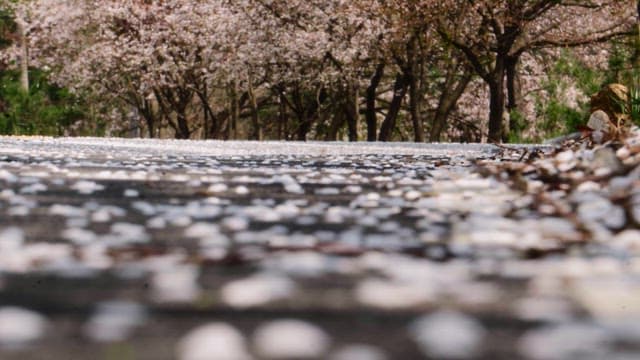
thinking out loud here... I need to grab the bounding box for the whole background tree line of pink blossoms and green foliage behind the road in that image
[0,0,638,142]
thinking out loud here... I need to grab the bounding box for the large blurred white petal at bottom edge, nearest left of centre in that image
[253,319,331,359]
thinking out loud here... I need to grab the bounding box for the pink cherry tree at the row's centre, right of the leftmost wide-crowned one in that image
[238,0,382,140]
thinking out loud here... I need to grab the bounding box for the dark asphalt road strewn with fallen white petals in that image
[0,137,640,360]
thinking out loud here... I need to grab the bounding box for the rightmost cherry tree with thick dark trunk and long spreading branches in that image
[439,0,634,142]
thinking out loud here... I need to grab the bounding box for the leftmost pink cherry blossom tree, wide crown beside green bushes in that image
[15,0,245,138]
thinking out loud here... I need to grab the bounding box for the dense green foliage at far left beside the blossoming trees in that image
[0,70,84,136]
